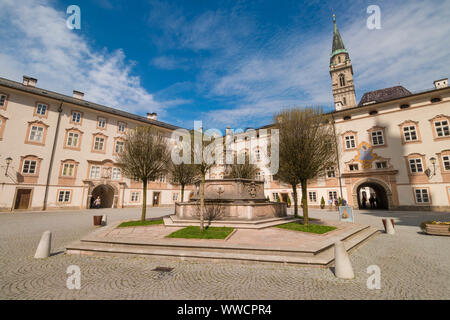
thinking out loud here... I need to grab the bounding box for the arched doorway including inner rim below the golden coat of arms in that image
[353,178,393,210]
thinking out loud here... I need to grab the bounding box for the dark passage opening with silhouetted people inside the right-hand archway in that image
[356,182,389,210]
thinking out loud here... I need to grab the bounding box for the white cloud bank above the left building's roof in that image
[0,0,172,114]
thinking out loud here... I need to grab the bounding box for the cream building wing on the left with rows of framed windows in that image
[0,76,186,211]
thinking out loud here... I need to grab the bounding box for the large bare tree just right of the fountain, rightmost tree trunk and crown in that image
[275,107,336,225]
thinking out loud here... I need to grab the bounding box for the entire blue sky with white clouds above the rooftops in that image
[0,0,450,130]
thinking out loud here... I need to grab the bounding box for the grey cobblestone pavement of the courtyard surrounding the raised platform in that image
[0,208,450,299]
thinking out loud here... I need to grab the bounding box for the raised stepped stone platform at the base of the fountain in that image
[66,221,378,267]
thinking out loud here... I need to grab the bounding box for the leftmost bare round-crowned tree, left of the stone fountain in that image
[116,126,170,221]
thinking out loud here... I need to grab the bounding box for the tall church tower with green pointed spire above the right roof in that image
[330,14,356,110]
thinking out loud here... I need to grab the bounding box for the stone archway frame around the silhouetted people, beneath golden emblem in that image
[352,178,395,210]
